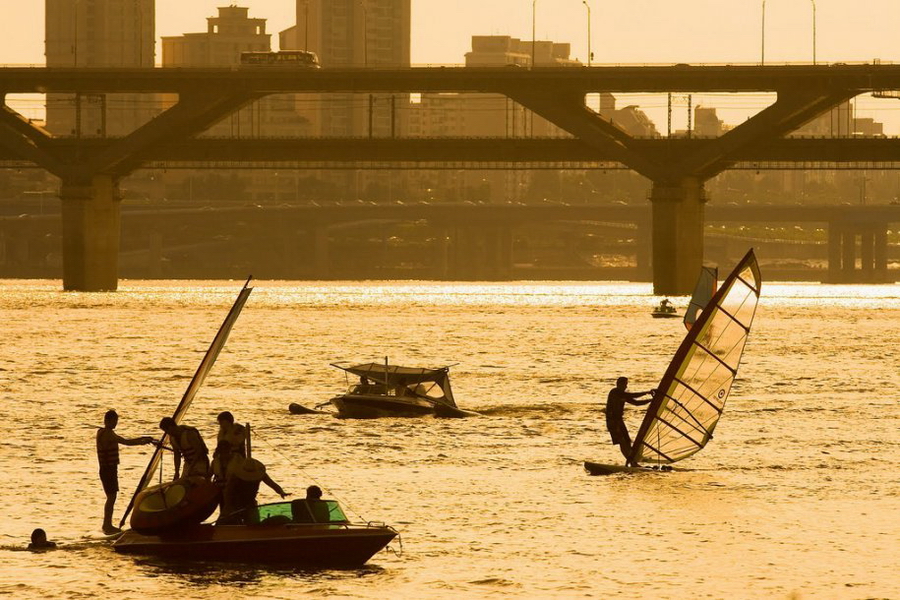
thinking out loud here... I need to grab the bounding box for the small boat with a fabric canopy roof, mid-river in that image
[326,359,476,419]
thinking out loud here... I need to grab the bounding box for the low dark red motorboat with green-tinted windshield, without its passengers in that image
[113,500,397,568]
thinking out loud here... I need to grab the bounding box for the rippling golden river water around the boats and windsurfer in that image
[0,274,900,598]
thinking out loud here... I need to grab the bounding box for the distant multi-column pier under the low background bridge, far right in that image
[828,222,888,283]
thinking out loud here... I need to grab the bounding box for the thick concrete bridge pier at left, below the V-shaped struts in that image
[59,175,121,292]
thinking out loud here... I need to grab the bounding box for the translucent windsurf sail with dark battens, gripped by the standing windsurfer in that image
[628,250,762,464]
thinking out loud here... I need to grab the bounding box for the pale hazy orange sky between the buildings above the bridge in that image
[0,0,900,133]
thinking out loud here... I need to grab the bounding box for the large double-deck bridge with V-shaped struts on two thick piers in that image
[0,64,900,294]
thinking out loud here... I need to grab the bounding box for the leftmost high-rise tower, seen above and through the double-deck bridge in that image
[45,0,159,137]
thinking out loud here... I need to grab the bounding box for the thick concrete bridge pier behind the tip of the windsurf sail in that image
[650,177,706,296]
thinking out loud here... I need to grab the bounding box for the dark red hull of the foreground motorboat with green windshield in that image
[113,523,397,568]
